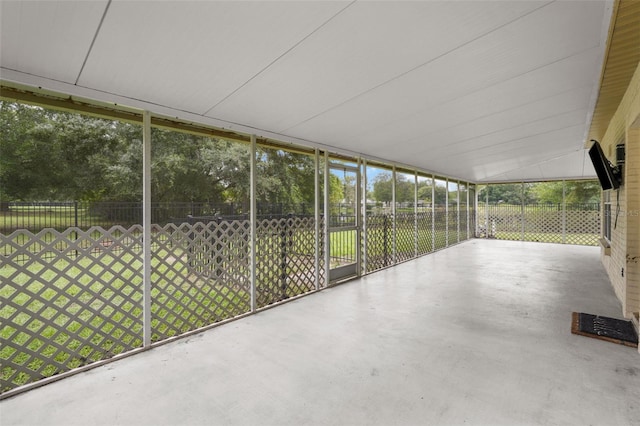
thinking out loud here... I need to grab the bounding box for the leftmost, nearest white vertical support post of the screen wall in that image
[142,111,151,347]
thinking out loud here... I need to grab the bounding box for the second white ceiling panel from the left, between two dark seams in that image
[79,1,348,115]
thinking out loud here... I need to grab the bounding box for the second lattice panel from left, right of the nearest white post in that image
[151,220,251,341]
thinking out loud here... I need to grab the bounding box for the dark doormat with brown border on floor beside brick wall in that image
[571,312,638,348]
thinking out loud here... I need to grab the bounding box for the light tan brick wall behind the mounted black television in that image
[601,61,640,324]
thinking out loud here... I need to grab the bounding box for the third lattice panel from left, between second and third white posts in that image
[256,217,322,307]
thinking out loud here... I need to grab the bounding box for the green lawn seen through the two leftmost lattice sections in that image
[0,240,250,392]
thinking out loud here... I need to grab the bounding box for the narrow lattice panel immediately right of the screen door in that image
[367,214,393,273]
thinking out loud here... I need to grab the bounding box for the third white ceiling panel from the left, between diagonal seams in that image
[208,2,543,131]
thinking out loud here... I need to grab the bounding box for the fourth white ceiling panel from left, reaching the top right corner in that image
[286,2,603,146]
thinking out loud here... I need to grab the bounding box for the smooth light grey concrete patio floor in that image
[0,240,640,426]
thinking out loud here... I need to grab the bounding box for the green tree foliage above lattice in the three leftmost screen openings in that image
[0,102,315,206]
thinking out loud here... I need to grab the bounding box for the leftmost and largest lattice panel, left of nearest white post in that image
[0,225,142,392]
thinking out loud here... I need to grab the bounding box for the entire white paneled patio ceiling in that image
[0,0,612,182]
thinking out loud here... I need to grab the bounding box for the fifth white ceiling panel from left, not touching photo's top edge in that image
[354,48,599,150]
